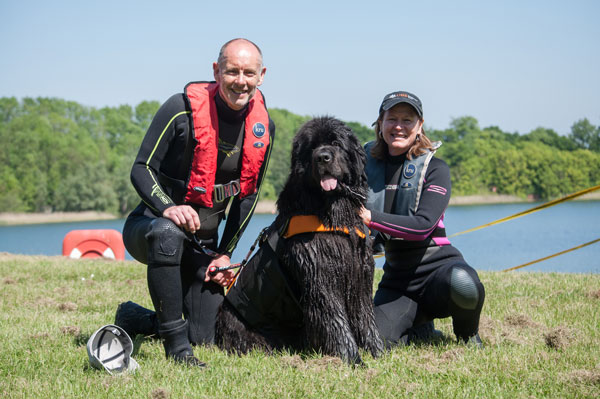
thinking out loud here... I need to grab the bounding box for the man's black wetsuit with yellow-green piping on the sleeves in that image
[123,93,275,343]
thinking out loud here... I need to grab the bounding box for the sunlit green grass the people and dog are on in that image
[0,254,600,399]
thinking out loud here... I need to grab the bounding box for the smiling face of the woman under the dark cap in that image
[380,103,423,155]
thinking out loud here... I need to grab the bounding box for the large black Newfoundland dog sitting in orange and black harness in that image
[215,117,383,363]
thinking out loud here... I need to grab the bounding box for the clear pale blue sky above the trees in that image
[0,0,600,134]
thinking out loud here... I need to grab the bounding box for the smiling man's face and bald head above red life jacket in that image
[213,41,267,111]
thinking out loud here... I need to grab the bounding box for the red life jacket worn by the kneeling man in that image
[185,82,269,208]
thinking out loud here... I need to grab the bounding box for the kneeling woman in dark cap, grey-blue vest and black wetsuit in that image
[361,91,485,347]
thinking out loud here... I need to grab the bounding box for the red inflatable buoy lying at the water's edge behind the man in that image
[63,230,125,260]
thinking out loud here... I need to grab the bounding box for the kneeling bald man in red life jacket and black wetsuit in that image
[115,39,275,367]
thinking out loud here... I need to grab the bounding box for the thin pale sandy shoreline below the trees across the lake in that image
[0,193,600,226]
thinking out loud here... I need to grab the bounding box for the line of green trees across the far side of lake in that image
[0,97,600,215]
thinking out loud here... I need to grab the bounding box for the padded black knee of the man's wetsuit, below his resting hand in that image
[146,218,186,266]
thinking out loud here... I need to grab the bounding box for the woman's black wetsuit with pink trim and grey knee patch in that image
[369,155,485,344]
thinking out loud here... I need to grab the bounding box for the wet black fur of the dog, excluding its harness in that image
[215,117,383,364]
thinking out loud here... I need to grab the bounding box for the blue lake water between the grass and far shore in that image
[0,201,600,273]
